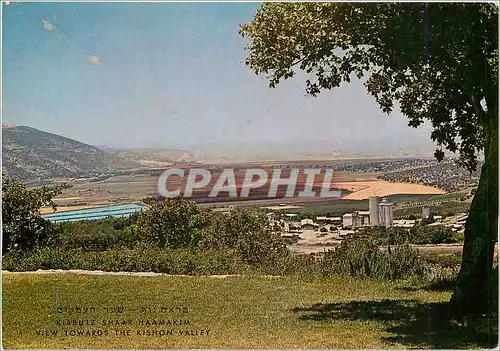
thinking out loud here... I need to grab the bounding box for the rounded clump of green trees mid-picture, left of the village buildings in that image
[135,198,287,265]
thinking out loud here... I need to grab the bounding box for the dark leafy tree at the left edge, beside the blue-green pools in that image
[2,180,61,252]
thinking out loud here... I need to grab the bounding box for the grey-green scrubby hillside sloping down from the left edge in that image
[2,126,138,182]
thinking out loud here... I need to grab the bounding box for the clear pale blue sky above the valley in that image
[2,2,432,154]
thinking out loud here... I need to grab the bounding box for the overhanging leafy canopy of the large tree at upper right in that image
[240,3,498,170]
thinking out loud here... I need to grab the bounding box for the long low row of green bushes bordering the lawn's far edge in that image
[3,237,424,279]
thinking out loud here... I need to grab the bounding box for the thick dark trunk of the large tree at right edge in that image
[450,111,498,317]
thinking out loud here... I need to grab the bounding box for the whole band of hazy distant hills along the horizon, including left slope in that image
[2,125,438,182]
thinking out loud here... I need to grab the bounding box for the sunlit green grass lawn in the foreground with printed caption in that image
[3,272,496,349]
